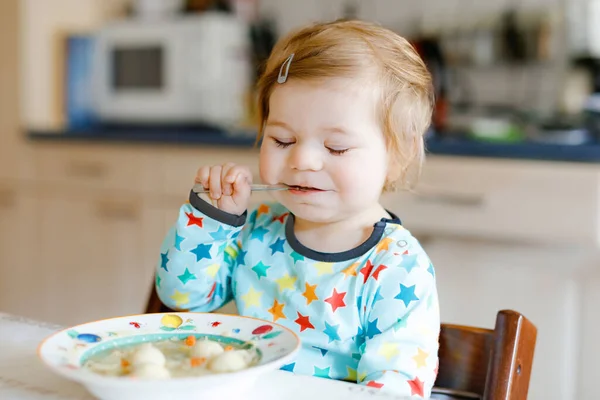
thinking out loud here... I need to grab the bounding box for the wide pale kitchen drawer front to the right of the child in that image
[384,156,599,245]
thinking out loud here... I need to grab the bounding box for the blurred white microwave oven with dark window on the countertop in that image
[91,12,252,127]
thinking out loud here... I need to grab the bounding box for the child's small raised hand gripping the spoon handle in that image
[196,163,252,215]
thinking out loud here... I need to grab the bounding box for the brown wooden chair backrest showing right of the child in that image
[432,310,537,400]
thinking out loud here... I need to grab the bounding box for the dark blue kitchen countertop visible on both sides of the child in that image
[27,127,600,163]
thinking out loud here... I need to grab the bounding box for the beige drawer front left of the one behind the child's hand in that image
[35,144,162,193]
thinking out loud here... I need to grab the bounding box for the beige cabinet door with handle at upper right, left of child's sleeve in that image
[39,191,152,325]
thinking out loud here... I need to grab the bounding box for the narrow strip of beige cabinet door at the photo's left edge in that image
[0,182,43,318]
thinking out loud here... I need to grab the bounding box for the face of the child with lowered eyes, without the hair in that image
[260,79,388,222]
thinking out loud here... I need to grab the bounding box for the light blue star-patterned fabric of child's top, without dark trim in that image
[156,192,440,397]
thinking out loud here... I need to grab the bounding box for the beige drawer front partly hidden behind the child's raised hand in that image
[162,147,260,197]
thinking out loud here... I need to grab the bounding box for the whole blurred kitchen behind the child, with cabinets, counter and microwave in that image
[0,0,600,400]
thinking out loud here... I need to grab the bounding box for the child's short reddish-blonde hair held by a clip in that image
[258,20,433,191]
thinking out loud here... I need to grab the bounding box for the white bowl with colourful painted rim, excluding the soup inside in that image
[38,312,300,400]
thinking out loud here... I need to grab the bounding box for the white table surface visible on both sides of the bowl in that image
[0,313,406,400]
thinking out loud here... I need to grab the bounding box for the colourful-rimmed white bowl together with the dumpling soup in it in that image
[38,312,300,400]
